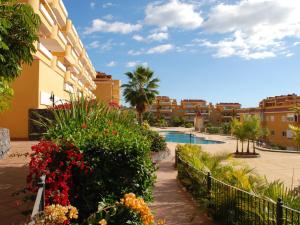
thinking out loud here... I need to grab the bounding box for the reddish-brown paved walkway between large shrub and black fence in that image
[151,145,215,225]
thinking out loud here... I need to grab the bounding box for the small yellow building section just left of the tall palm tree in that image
[93,72,121,106]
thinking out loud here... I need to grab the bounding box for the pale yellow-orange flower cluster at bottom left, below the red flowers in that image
[30,205,78,225]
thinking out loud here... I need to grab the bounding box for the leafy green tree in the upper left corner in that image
[0,0,40,112]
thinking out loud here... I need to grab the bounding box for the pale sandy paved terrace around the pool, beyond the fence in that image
[158,128,300,187]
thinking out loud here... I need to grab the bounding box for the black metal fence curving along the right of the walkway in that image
[176,153,300,225]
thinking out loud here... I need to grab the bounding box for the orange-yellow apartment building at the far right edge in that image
[239,94,300,149]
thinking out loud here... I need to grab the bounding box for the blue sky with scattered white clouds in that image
[64,0,300,107]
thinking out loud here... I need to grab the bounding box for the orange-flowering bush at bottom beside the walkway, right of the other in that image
[86,193,165,225]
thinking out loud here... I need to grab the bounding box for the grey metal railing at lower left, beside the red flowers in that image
[28,175,46,225]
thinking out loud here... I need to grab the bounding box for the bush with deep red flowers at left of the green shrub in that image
[27,141,88,206]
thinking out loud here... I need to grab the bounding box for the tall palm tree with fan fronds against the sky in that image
[122,66,159,124]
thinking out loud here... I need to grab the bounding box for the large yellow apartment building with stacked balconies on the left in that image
[0,0,96,139]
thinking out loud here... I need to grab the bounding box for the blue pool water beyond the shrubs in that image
[161,131,224,144]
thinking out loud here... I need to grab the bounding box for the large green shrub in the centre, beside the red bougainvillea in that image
[36,99,155,218]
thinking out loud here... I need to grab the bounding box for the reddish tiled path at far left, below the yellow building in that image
[0,141,35,225]
